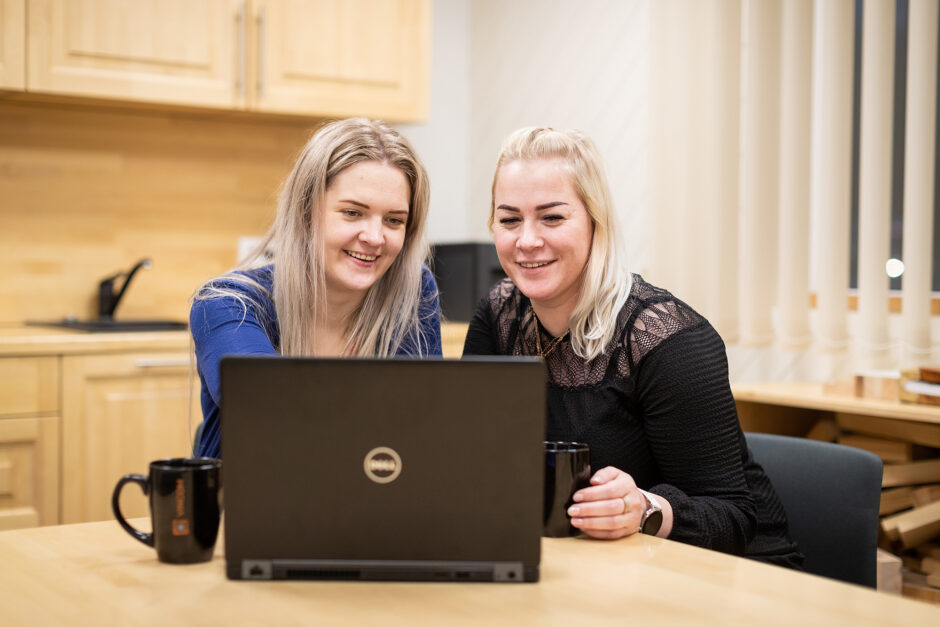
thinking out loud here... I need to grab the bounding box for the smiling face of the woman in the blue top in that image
[319,161,411,301]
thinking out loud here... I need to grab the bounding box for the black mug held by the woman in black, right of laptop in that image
[542,442,591,538]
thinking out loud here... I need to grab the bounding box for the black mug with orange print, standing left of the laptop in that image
[111,457,222,564]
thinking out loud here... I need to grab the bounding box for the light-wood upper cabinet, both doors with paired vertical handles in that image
[26,0,430,120]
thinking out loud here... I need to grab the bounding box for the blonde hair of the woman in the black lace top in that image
[487,127,633,360]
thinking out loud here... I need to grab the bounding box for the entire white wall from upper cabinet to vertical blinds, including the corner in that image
[399,0,649,260]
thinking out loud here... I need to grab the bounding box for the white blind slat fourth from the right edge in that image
[777,0,813,348]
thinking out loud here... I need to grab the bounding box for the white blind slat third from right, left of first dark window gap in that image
[812,0,855,351]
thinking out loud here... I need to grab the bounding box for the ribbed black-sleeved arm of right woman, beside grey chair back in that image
[635,322,757,554]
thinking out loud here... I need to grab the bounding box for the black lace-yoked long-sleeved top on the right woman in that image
[464,275,802,567]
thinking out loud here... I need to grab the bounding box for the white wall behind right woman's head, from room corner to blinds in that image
[469,0,649,267]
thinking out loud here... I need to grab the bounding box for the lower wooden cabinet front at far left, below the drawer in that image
[0,416,59,530]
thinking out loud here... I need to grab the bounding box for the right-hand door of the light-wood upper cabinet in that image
[249,0,431,121]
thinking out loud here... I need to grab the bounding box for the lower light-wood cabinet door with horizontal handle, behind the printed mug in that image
[62,353,202,523]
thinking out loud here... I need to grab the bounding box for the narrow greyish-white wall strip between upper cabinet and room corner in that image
[397,0,472,243]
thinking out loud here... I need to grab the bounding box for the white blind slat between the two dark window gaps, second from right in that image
[857,0,900,368]
